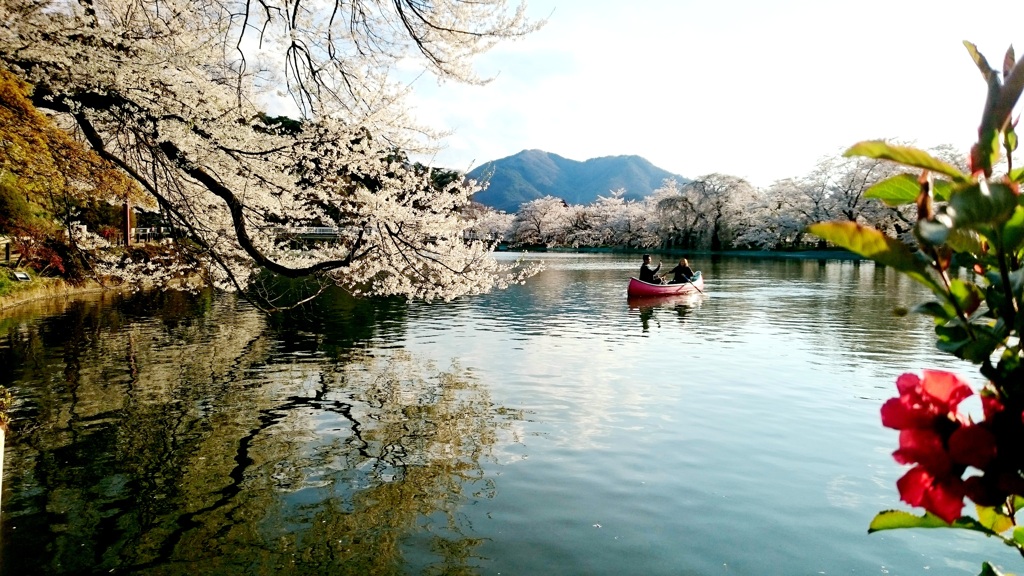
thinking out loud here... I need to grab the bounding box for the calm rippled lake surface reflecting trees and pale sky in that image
[0,254,1024,575]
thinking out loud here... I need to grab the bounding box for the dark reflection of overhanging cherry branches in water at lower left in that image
[0,291,512,574]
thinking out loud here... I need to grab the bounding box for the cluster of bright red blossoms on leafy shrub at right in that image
[882,370,974,523]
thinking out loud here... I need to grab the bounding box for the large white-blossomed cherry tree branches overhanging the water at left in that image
[0,0,537,299]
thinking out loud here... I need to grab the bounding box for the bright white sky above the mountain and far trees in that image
[411,0,1024,187]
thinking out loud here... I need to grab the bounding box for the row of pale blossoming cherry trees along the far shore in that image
[472,141,967,250]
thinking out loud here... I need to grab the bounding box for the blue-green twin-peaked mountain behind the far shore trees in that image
[468,150,690,212]
